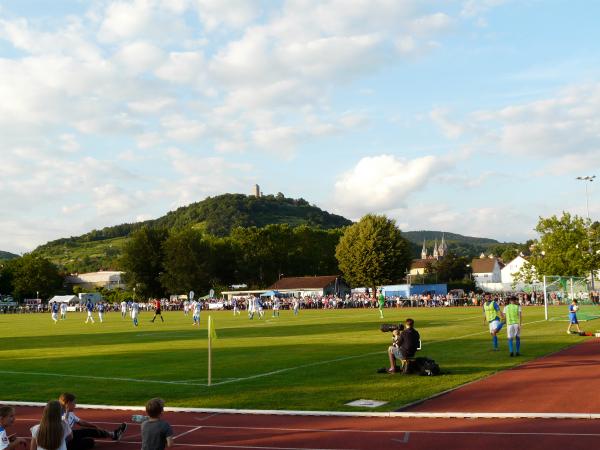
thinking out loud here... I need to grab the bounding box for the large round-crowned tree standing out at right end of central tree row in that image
[335,214,411,293]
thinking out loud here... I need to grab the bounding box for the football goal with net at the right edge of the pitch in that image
[543,275,600,321]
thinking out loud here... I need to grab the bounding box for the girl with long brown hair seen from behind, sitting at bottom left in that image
[30,400,72,450]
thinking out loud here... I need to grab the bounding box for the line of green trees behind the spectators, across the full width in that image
[0,213,600,299]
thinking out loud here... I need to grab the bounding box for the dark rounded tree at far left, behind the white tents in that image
[12,254,64,300]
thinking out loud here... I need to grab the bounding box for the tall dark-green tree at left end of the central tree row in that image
[121,227,168,298]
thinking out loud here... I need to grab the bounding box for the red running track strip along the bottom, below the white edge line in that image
[4,407,600,450]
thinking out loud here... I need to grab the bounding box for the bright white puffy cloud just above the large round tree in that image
[335,155,448,218]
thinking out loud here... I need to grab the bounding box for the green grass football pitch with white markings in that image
[0,307,600,411]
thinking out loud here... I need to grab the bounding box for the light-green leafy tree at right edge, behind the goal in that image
[529,212,600,276]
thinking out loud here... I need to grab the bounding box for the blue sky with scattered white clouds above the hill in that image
[0,0,600,253]
